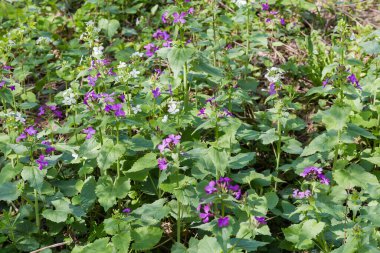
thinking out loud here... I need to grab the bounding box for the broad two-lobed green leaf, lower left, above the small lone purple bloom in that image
[95,176,131,211]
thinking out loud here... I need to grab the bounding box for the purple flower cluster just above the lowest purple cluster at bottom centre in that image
[204,177,242,199]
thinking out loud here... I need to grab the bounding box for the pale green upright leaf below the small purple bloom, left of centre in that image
[97,140,125,173]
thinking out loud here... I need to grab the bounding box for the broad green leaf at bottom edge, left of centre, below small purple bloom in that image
[132,227,162,250]
